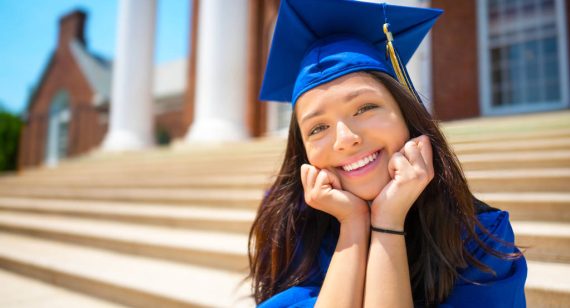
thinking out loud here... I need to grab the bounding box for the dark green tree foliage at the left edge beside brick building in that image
[0,107,22,171]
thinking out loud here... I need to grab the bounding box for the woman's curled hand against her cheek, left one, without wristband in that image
[301,164,370,223]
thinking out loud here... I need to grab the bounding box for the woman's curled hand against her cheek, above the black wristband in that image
[371,135,434,230]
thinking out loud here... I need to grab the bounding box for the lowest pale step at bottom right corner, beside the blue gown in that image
[525,261,570,308]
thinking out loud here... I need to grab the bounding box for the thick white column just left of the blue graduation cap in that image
[185,0,248,142]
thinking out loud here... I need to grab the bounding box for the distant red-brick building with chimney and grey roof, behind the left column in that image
[19,11,189,167]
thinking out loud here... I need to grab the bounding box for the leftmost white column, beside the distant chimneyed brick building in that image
[103,0,156,151]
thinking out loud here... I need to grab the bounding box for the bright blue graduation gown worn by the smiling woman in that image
[259,211,527,308]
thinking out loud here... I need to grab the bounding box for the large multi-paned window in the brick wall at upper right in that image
[478,0,568,114]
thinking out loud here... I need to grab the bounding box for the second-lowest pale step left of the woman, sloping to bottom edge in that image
[0,233,254,307]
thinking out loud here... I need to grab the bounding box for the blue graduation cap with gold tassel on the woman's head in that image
[260,0,443,106]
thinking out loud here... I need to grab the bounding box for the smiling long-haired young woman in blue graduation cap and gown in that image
[249,0,526,307]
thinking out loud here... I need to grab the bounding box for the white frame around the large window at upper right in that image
[477,0,570,116]
